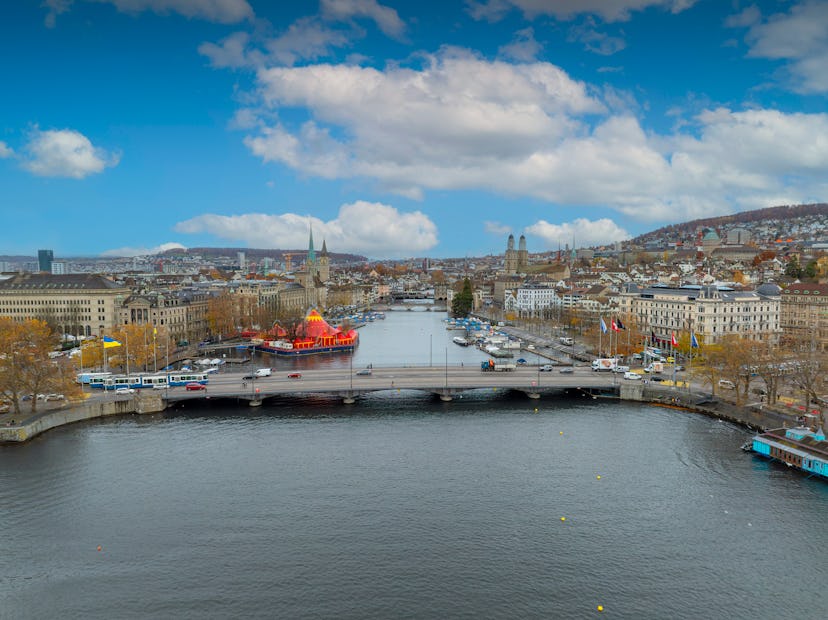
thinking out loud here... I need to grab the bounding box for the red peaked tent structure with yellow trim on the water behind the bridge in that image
[255,310,359,356]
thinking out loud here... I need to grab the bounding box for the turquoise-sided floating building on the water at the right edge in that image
[745,426,828,479]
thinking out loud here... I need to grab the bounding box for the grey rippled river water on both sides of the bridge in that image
[0,312,828,619]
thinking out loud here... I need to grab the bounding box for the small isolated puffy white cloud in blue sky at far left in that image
[23,129,120,179]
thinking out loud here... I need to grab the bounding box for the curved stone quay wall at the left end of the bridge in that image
[0,393,165,443]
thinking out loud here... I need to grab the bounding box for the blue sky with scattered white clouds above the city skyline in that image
[0,0,828,258]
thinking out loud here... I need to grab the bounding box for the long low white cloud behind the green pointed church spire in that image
[175,201,437,256]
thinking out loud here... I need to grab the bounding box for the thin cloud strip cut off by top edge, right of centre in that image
[466,0,696,22]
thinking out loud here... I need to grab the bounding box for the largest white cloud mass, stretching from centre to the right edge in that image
[236,48,828,221]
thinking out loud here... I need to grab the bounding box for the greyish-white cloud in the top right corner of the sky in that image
[735,1,828,93]
